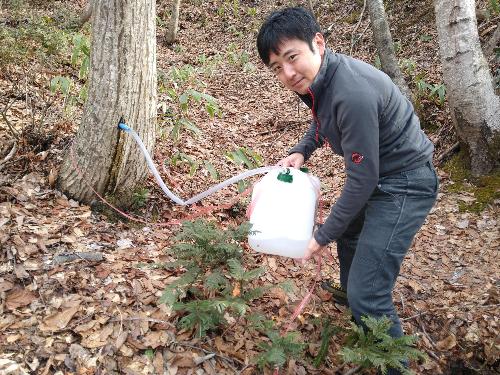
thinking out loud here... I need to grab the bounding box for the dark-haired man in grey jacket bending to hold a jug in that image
[257,8,438,375]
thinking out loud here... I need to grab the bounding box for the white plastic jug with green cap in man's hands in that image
[247,168,320,258]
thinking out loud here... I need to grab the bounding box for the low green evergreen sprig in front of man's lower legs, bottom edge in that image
[340,317,426,375]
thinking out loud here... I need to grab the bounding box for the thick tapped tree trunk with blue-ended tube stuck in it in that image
[58,0,156,207]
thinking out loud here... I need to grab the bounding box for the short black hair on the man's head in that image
[257,7,321,65]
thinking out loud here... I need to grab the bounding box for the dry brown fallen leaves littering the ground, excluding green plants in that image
[0,2,500,374]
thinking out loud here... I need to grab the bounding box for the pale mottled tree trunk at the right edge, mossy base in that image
[434,0,500,176]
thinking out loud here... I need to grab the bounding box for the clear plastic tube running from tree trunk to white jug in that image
[119,128,281,206]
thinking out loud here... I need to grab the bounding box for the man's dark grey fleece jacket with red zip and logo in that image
[289,49,434,245]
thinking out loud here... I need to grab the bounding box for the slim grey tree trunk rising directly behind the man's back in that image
[367,0,412,101]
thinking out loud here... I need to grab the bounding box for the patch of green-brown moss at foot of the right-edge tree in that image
[443,153,500,213]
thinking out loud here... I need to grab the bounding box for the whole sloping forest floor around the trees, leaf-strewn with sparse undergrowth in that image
[0,0,500,375]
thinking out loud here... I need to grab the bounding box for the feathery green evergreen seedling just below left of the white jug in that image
[160,220,292,337]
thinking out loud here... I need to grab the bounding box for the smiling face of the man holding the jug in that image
[269,33,325,94]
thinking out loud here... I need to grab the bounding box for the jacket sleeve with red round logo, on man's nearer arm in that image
[314,90,379,246]
